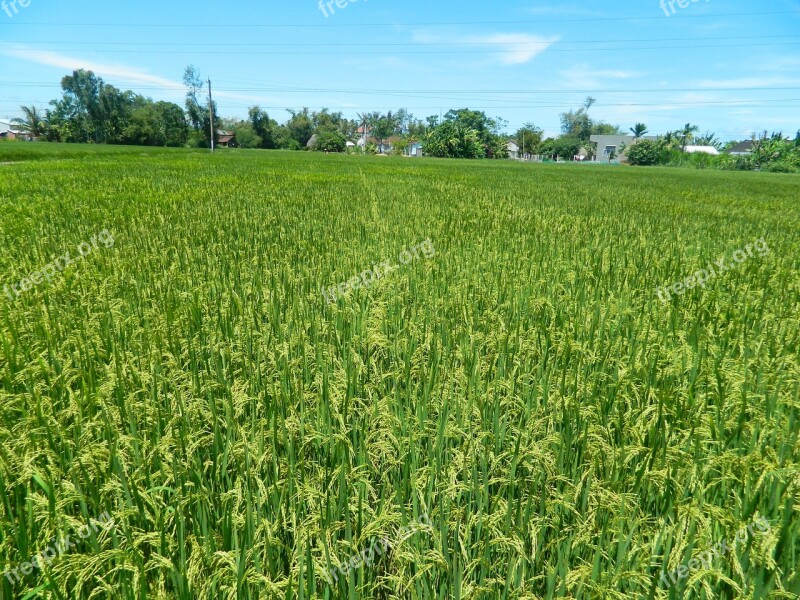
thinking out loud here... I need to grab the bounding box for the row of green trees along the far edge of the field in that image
[7,66,800,169]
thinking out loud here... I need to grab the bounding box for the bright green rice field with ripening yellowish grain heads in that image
[0,143,800,600]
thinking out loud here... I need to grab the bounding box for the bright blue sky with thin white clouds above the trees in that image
[0,0,800,140]
